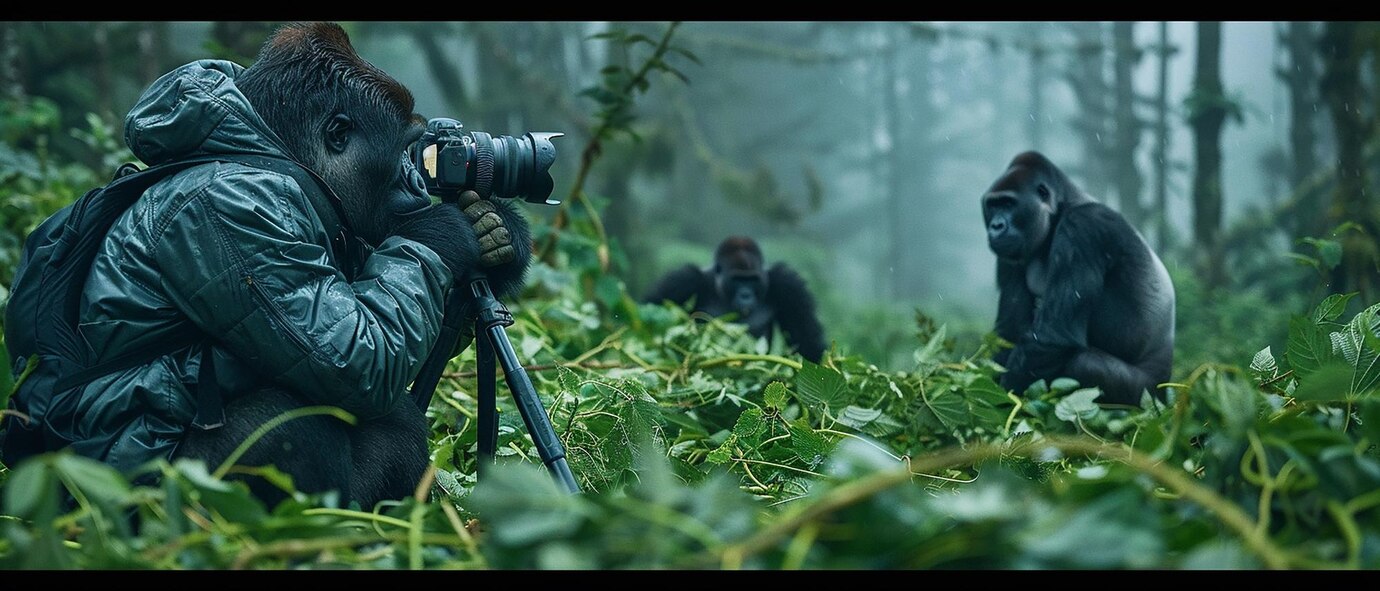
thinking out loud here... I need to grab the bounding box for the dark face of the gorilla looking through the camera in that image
[315,112,431,246]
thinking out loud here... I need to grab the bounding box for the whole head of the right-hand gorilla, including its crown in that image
[983,152,1087,262]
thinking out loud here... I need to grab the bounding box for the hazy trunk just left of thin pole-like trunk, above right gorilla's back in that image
[1112,21,1147,228]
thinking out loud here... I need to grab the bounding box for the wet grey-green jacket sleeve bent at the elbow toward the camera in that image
[155,167,451,418]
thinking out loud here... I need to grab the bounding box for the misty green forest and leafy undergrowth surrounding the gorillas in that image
[0,21,1380,569]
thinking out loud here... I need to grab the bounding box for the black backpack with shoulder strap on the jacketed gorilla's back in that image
[0,155,344,467]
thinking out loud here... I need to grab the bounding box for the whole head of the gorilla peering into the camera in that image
[236,23,431,244]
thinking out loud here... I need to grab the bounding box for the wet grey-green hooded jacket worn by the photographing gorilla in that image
[55,59,453,471]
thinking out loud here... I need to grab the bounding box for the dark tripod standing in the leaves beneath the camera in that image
[411,272,580,493]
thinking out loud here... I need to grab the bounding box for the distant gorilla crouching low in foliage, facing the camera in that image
[643,236,825,363]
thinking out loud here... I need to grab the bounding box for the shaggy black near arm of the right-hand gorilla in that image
[1002,204,1119,392]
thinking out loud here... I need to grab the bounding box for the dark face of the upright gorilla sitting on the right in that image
[983,166,1057,262]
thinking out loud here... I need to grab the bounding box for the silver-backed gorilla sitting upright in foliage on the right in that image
[983,152,1174,405]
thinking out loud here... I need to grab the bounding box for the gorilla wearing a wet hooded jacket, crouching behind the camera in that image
[57,23,530,507]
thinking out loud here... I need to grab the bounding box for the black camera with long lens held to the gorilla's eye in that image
[410,117,564,206]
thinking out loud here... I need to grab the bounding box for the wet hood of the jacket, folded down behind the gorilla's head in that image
[124,59,296,166]
